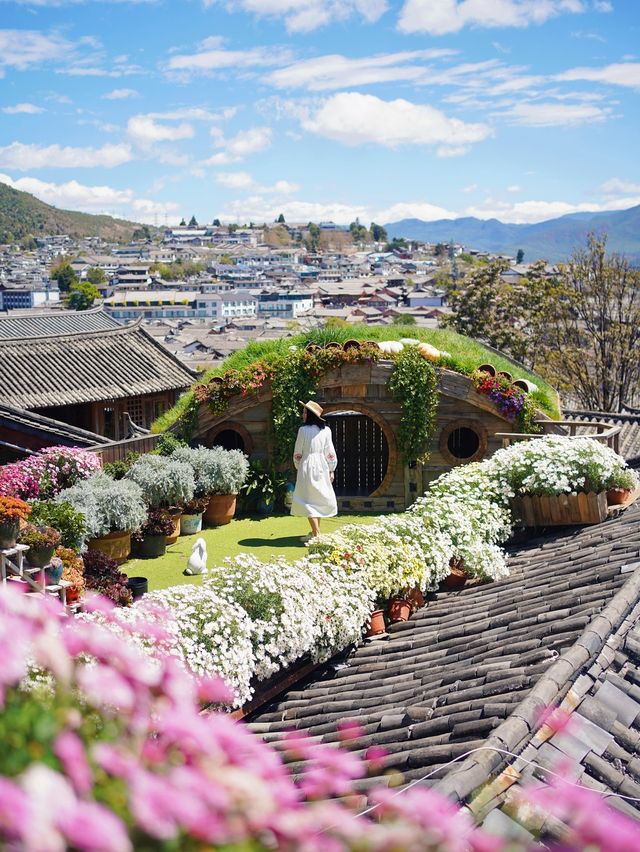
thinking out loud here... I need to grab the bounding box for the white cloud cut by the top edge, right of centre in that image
[398,0,584,35]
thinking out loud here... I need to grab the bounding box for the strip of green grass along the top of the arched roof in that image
[151,325,559,432]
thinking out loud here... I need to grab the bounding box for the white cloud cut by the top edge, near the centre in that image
[204,0,388,33]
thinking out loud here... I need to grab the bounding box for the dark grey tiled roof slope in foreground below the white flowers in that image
[250,505,640,799]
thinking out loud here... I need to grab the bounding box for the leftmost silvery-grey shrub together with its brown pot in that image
[56,473,147,564]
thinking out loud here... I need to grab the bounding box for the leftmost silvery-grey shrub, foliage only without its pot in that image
[56,473,147,538]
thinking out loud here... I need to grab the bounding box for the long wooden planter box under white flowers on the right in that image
[511,491,607,527]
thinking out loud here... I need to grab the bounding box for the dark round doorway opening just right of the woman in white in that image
[325,411,389,497]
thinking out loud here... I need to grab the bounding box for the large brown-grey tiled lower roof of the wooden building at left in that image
[0,322,194,409]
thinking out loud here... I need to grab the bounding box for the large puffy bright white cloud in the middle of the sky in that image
[301,92,491,156]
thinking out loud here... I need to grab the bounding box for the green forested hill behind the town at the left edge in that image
[0,183,148,243]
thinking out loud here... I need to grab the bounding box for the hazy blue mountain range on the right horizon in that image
[384,205,640,265]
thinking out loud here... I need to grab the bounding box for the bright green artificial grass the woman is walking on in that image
[122,514,378,591]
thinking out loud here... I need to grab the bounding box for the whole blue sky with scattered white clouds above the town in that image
[0,0,640,226]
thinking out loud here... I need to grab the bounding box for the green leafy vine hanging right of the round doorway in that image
[389,346,438,463]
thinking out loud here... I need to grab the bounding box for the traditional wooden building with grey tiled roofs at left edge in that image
[0,310,195,440]
